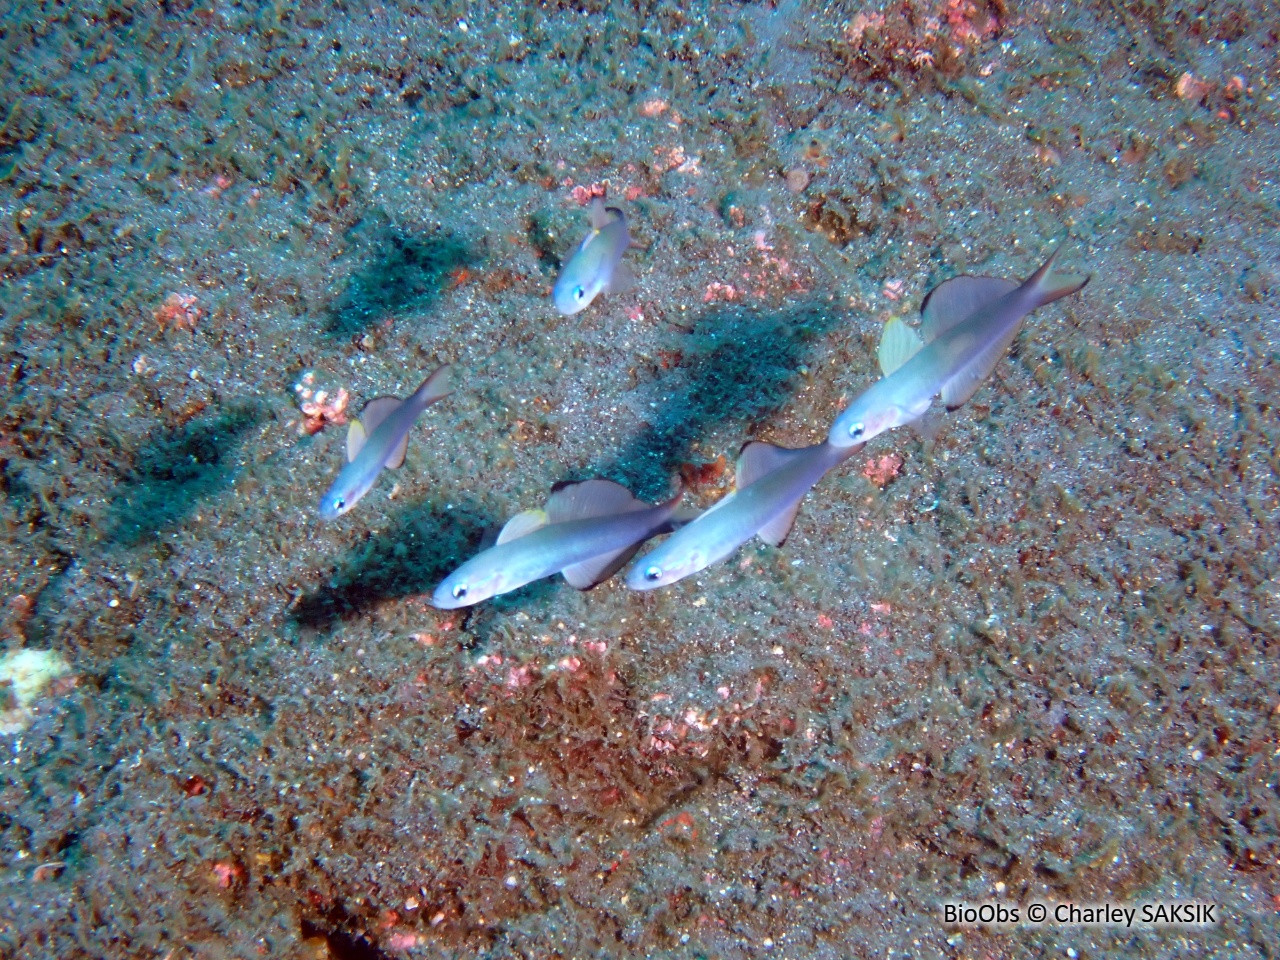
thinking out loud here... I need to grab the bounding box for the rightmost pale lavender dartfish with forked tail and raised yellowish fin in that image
[827,250,1089,447]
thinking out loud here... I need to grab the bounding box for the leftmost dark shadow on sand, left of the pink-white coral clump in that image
[104,403,264,547]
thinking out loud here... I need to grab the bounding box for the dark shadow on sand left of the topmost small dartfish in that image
[325,210,484,337]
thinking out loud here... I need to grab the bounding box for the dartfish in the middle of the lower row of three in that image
[627,442,861,590]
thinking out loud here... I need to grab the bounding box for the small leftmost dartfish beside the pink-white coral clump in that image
[320,364,452,520]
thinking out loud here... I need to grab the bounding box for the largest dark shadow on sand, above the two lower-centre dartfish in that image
[595,301,845,500]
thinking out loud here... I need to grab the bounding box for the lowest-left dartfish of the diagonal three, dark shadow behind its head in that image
[431,480,681,609]
